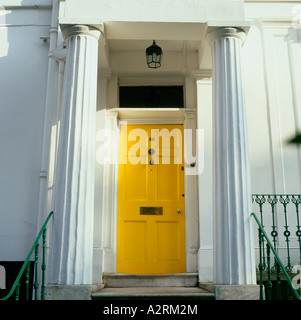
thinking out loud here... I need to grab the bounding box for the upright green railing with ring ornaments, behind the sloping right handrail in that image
[252,194,301,272]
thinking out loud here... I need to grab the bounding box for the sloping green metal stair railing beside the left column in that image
[0,212,53,300]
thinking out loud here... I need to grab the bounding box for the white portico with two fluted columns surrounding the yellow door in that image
[43,1,257,299]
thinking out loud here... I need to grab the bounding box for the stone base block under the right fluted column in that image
[215,285,260,300]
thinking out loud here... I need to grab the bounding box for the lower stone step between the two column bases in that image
[92,287,215,300]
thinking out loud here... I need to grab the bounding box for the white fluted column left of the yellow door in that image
[48,25,100,298]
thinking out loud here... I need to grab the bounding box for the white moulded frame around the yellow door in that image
[101,108,199,273]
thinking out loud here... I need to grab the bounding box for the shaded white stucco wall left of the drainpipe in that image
[0,0,51,261]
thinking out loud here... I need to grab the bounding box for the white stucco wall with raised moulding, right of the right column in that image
[243,2,301,265]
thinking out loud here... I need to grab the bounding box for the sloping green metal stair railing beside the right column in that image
[251,213,301,300]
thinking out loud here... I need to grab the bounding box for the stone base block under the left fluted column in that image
[45,284,92,300]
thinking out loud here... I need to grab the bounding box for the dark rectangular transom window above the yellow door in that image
[119,86,184,108]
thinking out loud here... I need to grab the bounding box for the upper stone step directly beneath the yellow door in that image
[103,273,198,288]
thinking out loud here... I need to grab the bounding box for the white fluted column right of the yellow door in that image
[211,28,257,299]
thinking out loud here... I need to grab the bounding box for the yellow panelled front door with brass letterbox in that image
[117,125,186,274]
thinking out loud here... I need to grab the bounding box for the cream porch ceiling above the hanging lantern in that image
[99,21,207,69]
